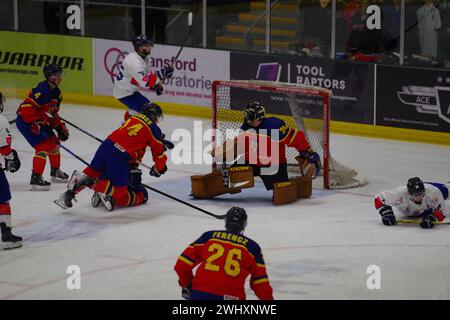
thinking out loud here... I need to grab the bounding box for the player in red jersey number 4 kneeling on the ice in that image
[55,103,167,210]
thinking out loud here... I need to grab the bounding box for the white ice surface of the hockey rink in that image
[0,99,450,300]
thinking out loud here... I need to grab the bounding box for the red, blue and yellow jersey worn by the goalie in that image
[237,117,311,166]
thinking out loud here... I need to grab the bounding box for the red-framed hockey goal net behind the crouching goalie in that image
[212,80,366,189]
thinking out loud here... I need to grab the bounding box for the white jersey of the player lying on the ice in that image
[376,183,448,217]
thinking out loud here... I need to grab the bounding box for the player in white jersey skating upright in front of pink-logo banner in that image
[114,35,174,118]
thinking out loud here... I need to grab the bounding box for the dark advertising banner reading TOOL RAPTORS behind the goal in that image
[230,52,374,124]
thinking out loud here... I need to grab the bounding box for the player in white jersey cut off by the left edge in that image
[0,92,22,250]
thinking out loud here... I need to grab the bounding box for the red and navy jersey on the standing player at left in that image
[17,81,62,127]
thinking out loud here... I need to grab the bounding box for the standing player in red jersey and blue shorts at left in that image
[16,64,69,190]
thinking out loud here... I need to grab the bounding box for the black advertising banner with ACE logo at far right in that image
[376,66,450,132]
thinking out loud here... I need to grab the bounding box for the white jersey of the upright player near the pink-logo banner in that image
[113,52,150,99]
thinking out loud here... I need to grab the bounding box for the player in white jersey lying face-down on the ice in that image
[375,177,449,229]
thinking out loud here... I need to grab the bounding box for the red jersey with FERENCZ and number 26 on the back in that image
[174,231,273,300]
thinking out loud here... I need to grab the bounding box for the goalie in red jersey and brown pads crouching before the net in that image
[191,102,321,204]
